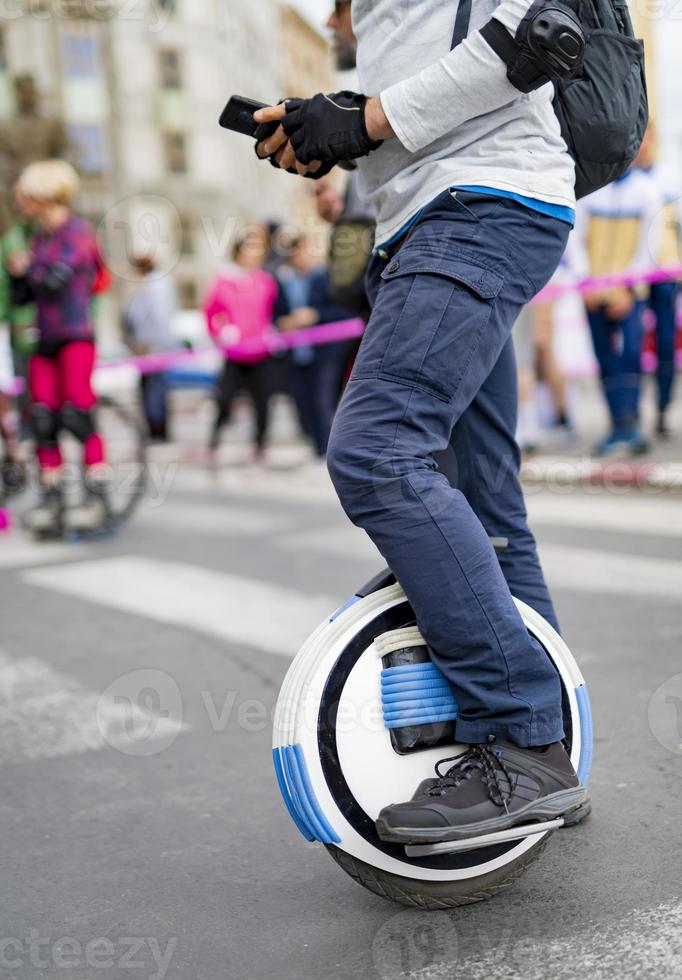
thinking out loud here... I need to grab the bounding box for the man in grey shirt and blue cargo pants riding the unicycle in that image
[255,0,644,844]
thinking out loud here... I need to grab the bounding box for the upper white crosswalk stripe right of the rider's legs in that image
[526,491,682,538]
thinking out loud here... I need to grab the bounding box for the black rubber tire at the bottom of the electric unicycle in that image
[325,833,552,911]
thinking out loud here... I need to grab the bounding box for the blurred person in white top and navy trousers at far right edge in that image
[635,125,682,439]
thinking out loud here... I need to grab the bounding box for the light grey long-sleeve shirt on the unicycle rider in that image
[352,0,575,243]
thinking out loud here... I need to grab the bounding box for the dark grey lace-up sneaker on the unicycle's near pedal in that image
[376,742,588,844]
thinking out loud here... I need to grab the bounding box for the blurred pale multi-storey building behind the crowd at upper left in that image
[0,0,331,322]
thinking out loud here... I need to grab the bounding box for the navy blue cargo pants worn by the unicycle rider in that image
[328,191,570,746]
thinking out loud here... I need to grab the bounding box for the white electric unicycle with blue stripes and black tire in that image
[273,552,592,909]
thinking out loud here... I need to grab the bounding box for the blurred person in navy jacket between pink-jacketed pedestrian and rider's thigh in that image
[276,238,351,459]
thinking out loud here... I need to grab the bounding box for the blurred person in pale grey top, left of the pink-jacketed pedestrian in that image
[123,255,178,442]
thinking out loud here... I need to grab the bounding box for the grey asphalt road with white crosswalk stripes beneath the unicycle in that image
[0,457,682,980]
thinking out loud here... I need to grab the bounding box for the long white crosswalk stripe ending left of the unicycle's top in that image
[22,557,339,657]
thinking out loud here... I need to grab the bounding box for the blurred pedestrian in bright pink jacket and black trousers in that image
[204,226,278,459]
